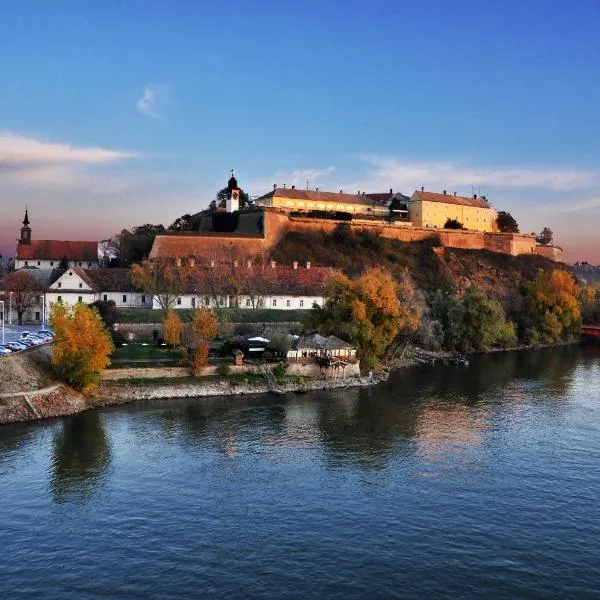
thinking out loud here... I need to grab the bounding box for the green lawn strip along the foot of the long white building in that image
[117,308,310,323]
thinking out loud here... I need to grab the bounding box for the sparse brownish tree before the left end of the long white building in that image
[130,260,191,310]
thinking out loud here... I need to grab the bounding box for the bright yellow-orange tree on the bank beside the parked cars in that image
[50,302,114,392]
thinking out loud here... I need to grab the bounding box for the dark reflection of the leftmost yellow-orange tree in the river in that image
[50,411,111,503]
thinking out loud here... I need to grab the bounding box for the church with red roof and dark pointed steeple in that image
[15,208,99,270]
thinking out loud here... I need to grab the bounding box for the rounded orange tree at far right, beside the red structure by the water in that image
[526,269,581,344]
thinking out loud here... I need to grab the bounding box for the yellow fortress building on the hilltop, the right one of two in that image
[408,188,498,232]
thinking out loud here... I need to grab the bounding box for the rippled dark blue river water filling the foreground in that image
[0,347,600,599]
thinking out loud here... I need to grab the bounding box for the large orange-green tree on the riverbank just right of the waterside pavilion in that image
[308,268,417,367]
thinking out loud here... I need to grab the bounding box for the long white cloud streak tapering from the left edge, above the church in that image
[0,131,139,170]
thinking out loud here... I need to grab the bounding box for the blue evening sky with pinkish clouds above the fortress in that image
[0,0,600,264]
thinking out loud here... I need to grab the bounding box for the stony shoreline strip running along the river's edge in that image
[0,340,580,425]
